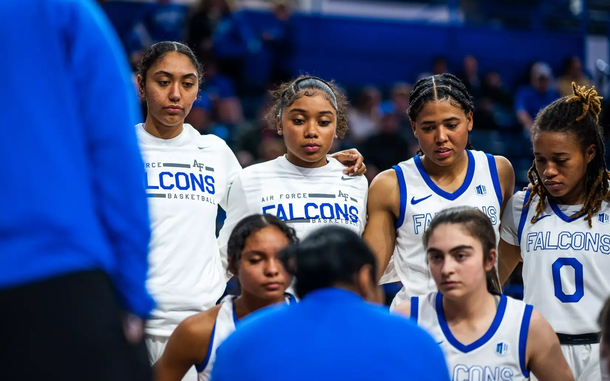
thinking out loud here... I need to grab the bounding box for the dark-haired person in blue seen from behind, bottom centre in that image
[212,226,449,381]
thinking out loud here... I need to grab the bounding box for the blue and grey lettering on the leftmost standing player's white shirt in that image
[144,159,216,205]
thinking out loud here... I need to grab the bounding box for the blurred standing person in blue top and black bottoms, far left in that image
[0,0,154,381]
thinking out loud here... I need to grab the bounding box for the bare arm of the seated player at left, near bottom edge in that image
[155,305,220,381]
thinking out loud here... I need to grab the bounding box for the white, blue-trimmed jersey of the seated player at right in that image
[411,292,533,381]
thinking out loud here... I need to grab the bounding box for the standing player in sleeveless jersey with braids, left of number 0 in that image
[364,74,515,308]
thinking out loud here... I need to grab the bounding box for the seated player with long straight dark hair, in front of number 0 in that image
[397,206,574,381]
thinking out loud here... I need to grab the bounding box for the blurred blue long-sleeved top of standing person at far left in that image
[0,0,154,317]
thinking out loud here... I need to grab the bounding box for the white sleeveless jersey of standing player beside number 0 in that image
[386,150,502,306]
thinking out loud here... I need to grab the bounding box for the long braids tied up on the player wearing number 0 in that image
[525,82,610,227]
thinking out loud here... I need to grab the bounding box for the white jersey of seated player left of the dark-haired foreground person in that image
[195,293,296,381]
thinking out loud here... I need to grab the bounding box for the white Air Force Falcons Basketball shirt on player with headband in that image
[218,156,368,255]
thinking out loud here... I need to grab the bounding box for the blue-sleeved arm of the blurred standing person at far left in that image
[65,1,154,318]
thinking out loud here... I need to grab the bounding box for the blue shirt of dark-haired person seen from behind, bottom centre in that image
[212,288,449,381]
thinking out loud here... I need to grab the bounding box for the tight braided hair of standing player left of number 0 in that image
[407,73,474,155]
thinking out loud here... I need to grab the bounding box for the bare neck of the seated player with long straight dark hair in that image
[443,287,496,321]
